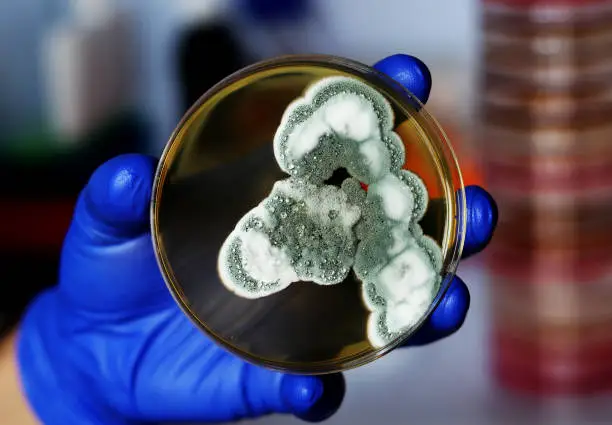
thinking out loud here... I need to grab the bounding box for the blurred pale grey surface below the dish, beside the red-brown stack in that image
[247,261,612,425]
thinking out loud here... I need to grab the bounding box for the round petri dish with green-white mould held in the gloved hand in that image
[151,56,466,374]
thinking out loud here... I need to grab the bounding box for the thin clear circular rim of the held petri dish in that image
[150,55,467,375]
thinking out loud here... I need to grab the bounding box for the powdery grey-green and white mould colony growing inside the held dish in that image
[218,77,442,348]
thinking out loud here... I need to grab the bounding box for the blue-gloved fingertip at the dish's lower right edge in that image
[405,276,470,347]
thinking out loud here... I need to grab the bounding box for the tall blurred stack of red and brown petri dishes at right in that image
[479,0,612,394]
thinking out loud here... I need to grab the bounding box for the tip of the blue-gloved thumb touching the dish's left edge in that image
[83,154,156,234]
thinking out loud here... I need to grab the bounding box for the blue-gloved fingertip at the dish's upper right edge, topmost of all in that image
[374,54,431,104]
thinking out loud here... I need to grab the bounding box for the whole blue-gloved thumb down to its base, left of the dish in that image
[59,155,171,314]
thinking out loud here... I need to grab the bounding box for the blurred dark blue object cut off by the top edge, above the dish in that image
[239,0,312,23]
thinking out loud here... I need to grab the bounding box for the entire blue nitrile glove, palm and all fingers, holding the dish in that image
[18,56,497,425]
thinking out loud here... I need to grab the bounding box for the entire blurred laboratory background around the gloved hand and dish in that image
[0,0,612,425]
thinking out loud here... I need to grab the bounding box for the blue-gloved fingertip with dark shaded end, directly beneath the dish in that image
[281,373,346,422]
